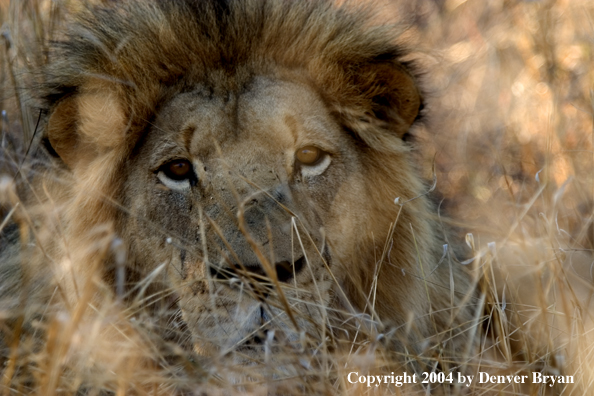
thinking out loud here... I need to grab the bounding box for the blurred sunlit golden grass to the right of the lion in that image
[402,0,594,395]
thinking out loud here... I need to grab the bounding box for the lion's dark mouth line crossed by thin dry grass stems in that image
[210,256,305,284]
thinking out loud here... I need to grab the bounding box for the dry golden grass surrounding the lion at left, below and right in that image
[0,0,594,395]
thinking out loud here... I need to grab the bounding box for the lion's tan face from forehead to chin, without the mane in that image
[122,77,366,351]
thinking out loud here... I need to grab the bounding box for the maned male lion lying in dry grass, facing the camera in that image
[0,0,475,386]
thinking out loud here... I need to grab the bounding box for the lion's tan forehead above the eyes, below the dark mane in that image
[149,77,344,165]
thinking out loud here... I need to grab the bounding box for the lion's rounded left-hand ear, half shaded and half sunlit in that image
[47,84,126,169]
